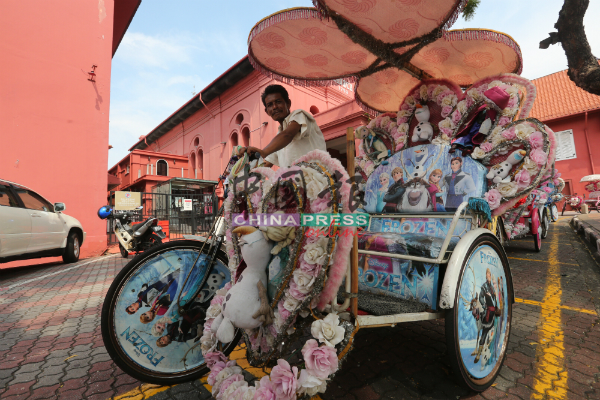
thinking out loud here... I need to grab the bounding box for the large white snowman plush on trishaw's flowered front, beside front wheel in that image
[211,226,273,343]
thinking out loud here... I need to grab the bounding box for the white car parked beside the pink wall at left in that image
[0,179,85,263]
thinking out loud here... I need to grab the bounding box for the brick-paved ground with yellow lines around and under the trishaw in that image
[0,217,600,400]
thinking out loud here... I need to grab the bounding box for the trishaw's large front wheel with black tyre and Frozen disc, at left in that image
[101,240,241,385]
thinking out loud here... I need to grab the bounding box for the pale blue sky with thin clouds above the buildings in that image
[107,0,600,169]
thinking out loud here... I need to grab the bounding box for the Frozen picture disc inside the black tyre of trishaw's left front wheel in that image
[115,249,230,373]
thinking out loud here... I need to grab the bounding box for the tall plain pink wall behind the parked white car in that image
[0,0,113,256]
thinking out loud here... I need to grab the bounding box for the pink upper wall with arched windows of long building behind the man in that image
[138,71,354,180]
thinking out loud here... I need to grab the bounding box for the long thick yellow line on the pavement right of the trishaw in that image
[531,230,569,400]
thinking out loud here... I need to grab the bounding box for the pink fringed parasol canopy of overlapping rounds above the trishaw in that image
[248,0,523,113]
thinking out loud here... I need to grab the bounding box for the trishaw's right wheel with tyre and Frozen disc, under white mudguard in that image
[446,234,513,392]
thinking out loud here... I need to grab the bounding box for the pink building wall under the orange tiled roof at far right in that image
[544,110,600,198]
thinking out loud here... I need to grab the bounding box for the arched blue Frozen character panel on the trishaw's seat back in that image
[365,144,487,214]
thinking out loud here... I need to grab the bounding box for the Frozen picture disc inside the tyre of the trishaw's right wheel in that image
[458,245,508,379]
